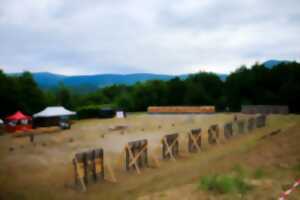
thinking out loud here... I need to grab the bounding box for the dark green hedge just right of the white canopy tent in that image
[77,104,115,119]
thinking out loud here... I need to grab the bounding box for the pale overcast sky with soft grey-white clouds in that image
[0,0,300,74]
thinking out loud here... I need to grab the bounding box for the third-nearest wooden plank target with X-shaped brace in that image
[162,133,179,160]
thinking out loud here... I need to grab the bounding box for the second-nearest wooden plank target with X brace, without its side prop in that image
[125,140,148,173]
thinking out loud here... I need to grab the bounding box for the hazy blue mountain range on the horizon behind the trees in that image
[10,60,289,92]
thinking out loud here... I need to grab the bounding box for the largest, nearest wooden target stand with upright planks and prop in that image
[73,149,117,192]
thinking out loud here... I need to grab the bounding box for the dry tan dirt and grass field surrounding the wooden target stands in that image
[0,114,300,200]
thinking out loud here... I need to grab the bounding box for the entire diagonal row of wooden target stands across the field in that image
[73,115,266,191]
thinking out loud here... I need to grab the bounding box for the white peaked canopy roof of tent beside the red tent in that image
[33,106,76,118]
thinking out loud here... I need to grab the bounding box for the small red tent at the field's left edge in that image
[5,111,32,132]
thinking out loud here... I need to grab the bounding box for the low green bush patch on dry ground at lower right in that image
[200,175,251,194]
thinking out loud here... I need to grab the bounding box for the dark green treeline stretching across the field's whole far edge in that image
[0,62,300,117]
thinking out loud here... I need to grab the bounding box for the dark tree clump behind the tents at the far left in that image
[0,70,75,118]
